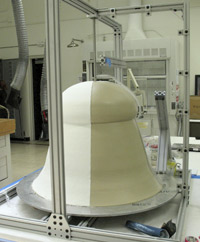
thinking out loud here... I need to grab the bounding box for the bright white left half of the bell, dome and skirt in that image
[32,82,92,206]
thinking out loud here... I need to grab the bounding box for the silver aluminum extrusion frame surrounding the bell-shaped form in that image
[0,0,190,242]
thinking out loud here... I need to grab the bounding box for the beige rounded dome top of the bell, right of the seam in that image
[91,82,137,123]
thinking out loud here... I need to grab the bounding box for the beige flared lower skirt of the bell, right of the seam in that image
[91,120,161,206]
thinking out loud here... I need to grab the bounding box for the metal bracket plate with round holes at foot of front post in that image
[47,213,71,239]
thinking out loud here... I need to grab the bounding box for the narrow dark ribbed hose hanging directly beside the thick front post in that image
[40,46,48,111]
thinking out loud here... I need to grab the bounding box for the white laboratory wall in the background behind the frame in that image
[0,0,200,139]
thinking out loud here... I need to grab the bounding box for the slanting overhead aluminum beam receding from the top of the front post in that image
[63,0,122,31]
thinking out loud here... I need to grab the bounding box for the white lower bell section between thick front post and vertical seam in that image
[64,124,91,206]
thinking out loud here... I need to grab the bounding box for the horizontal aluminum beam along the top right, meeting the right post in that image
[98,3,184,16]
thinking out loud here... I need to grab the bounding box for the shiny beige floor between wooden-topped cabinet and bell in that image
[11,143,48,182]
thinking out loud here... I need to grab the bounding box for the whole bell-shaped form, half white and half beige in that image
[32,82,162,207]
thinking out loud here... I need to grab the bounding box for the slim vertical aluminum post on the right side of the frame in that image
[183,0,190,199]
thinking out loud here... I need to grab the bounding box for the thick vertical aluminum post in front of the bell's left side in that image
[46,0,66,216]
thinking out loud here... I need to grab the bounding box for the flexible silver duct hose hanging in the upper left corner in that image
[10,0,29,91]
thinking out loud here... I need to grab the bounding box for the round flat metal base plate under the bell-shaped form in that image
[17,171,178,217]
